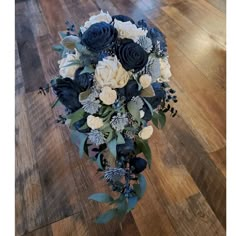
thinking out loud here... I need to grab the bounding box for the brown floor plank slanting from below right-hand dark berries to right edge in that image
[165,117,226,227]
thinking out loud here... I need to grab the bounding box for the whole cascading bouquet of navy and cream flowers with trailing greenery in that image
[40,11,177,223]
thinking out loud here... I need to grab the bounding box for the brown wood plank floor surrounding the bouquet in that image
[16,0,226,236]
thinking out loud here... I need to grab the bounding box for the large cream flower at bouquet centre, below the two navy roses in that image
[95,56,130,88]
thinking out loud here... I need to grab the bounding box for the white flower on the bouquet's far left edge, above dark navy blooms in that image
[58,49,80,79]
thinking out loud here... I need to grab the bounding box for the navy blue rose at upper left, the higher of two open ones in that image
[82,22,118,52]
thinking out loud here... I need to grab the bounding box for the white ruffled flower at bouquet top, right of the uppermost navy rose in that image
[114,19,147,42]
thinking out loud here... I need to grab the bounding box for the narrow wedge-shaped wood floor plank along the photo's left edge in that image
[15,41,47,235]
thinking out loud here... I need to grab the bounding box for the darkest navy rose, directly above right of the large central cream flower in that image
[116,39,148,73]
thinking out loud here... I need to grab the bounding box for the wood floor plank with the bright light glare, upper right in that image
[147,7,226,88]
